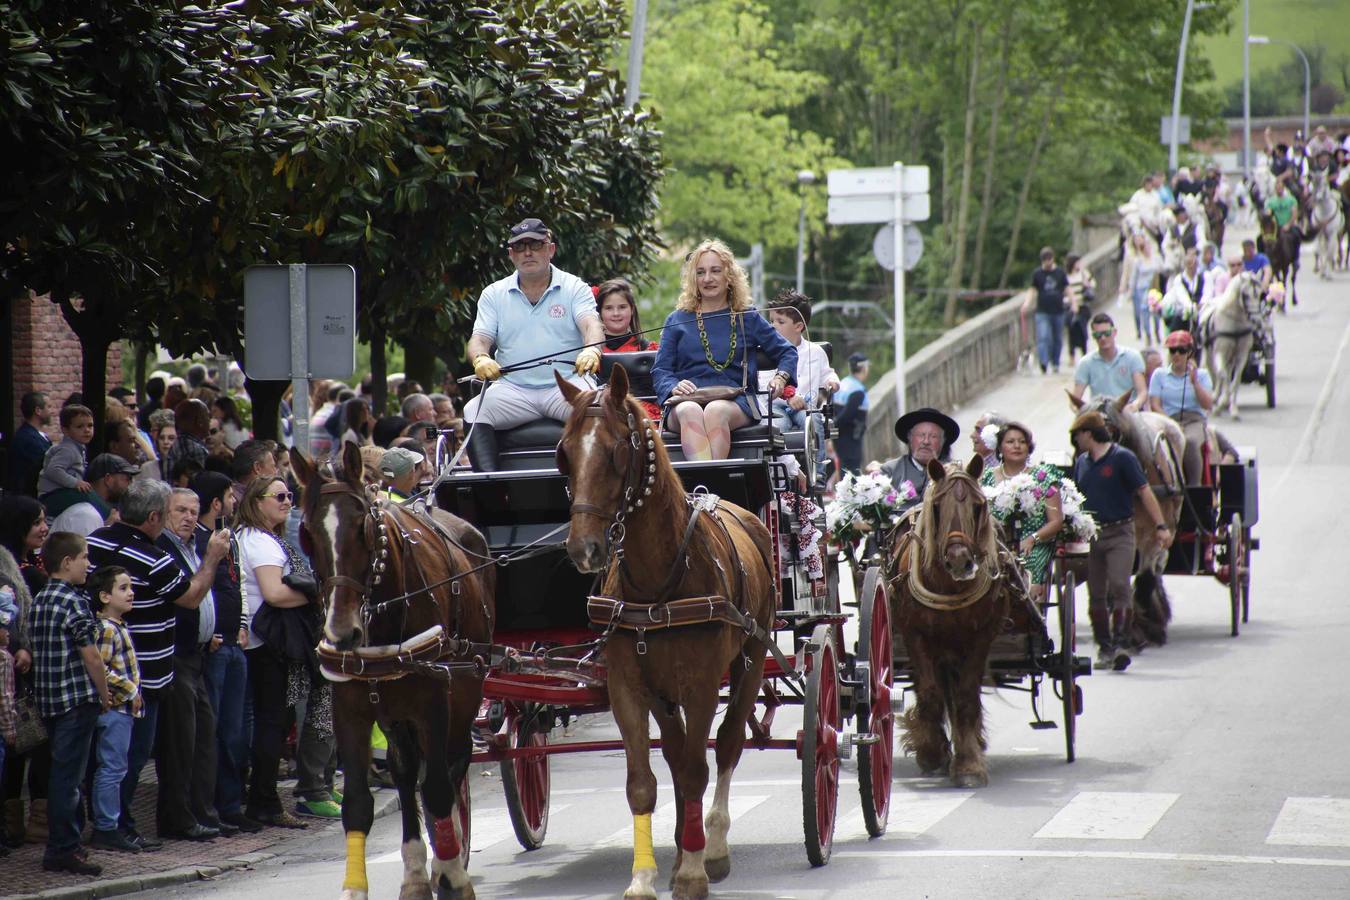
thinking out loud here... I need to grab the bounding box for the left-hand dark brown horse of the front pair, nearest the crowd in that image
[290,443,495,900]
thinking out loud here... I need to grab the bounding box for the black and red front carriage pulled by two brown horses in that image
[433,351,894,866]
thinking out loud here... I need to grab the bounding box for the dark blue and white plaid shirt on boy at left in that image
[28,578,99,718]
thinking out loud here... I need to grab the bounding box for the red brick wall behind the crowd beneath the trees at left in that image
[14,296,122,440]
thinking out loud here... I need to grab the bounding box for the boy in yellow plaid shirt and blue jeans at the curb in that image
[85,565,142,853]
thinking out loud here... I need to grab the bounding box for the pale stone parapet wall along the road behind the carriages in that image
[863,236,1121,461]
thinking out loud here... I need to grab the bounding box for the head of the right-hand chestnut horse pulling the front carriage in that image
[555,364,675,572]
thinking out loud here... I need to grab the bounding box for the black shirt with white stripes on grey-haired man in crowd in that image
[89,522,188,694]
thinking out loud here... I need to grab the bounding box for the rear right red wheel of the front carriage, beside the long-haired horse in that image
[857,565,895,838]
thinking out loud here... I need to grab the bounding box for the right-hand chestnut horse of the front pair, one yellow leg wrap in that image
[558,366,776,899]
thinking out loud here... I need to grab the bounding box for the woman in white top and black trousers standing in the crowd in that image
[235,478,309,828]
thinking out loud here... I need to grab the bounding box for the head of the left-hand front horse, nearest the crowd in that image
[290,441,389,650]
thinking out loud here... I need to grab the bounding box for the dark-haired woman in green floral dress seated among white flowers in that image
[980,422,1064,602]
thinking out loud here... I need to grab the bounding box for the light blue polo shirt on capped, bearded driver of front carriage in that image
[474,266,599,387]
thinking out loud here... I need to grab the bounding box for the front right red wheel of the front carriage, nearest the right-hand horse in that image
[798,625,841,866]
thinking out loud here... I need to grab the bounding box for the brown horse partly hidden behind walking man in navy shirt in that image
[1069,393,1185,646]
